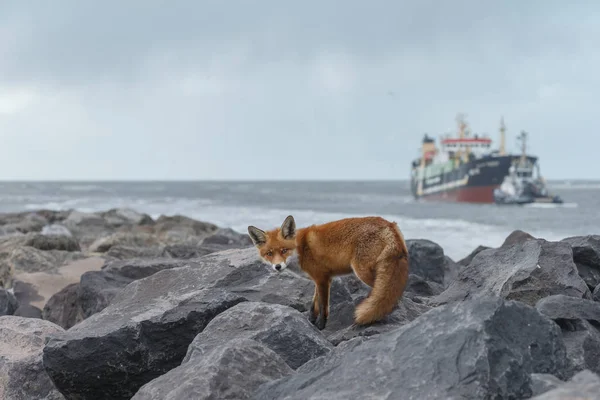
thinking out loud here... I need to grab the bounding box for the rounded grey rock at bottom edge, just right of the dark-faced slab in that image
[132,338,293,400]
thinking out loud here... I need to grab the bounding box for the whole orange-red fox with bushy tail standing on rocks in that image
[248,215,408,330]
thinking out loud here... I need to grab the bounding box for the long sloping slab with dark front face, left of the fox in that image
[44,248,314,399]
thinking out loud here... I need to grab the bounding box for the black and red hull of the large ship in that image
[411,155,536,203]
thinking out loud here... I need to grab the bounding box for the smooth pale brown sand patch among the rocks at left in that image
[14,257,105,309]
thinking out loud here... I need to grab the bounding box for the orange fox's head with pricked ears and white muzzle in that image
[248,215,296,272]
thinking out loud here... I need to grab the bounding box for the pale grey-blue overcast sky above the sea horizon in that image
[0,0,600,180]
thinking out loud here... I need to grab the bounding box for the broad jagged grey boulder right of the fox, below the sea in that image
[431,239,591,306]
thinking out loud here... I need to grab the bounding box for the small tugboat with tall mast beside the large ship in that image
[494,131,563,204]
